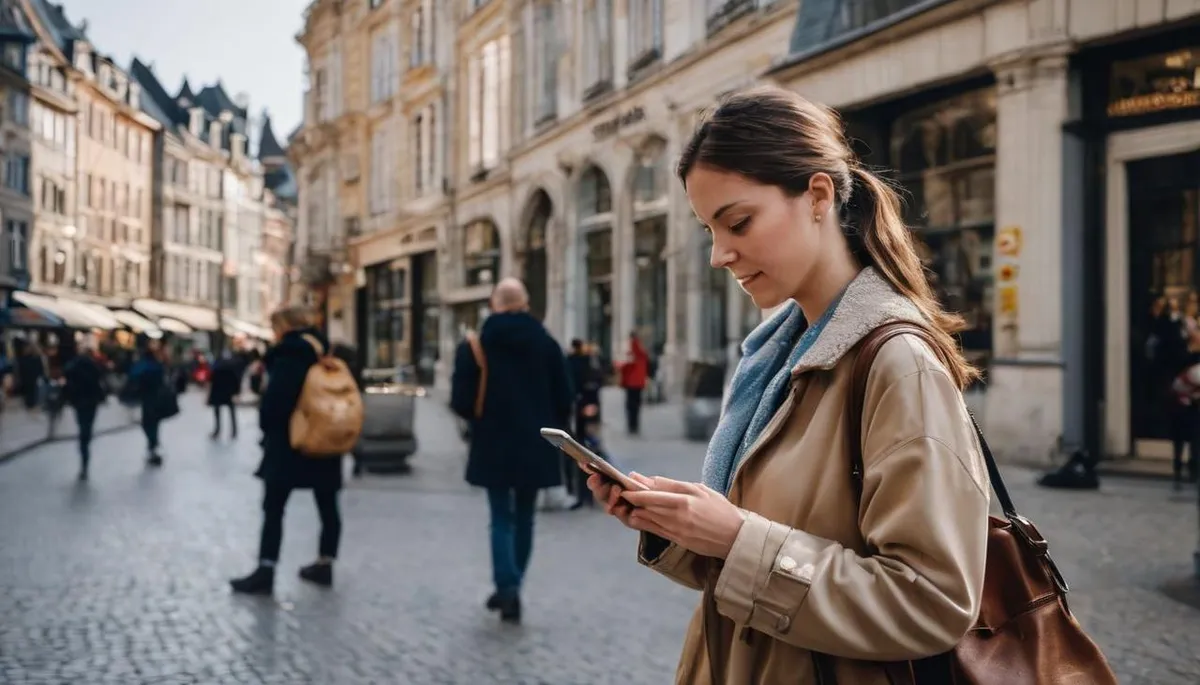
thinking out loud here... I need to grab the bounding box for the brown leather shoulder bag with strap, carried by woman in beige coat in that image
[814,322,1117,685]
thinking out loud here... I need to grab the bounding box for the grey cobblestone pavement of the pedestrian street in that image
[0,388,1200,685]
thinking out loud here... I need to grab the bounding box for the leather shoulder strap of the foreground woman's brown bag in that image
[847,322,1018,518]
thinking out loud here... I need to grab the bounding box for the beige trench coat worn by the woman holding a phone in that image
[638,269,991,685]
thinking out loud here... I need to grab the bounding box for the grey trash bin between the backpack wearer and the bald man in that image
[354,369,425,473]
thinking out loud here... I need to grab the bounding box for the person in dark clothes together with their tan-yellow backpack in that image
[229,307,362,595]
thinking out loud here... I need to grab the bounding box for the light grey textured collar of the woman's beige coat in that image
[792,266,929,375]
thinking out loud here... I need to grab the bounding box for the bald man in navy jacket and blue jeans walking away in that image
[450,278,574,623]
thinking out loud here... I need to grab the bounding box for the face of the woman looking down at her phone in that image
[686,164,833,310]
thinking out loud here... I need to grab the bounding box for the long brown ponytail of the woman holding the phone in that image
[846,164,979,390]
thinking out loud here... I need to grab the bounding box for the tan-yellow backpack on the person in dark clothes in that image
[288,335,362,458]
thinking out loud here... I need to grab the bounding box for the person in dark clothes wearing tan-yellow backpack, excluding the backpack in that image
[229,307,342,595]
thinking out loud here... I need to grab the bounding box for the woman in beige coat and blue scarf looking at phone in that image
[588,88,990,685]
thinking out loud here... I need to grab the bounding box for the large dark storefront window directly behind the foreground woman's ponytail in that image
[890,88,996,366]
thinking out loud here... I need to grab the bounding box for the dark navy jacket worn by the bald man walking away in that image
[450,312,574,489]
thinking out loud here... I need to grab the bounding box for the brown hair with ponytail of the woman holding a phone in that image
[676,86,979,387]
